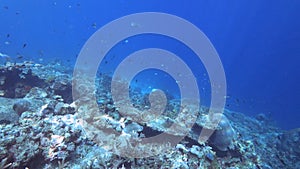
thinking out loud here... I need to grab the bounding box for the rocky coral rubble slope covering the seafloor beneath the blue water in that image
[0,62,300,169]
